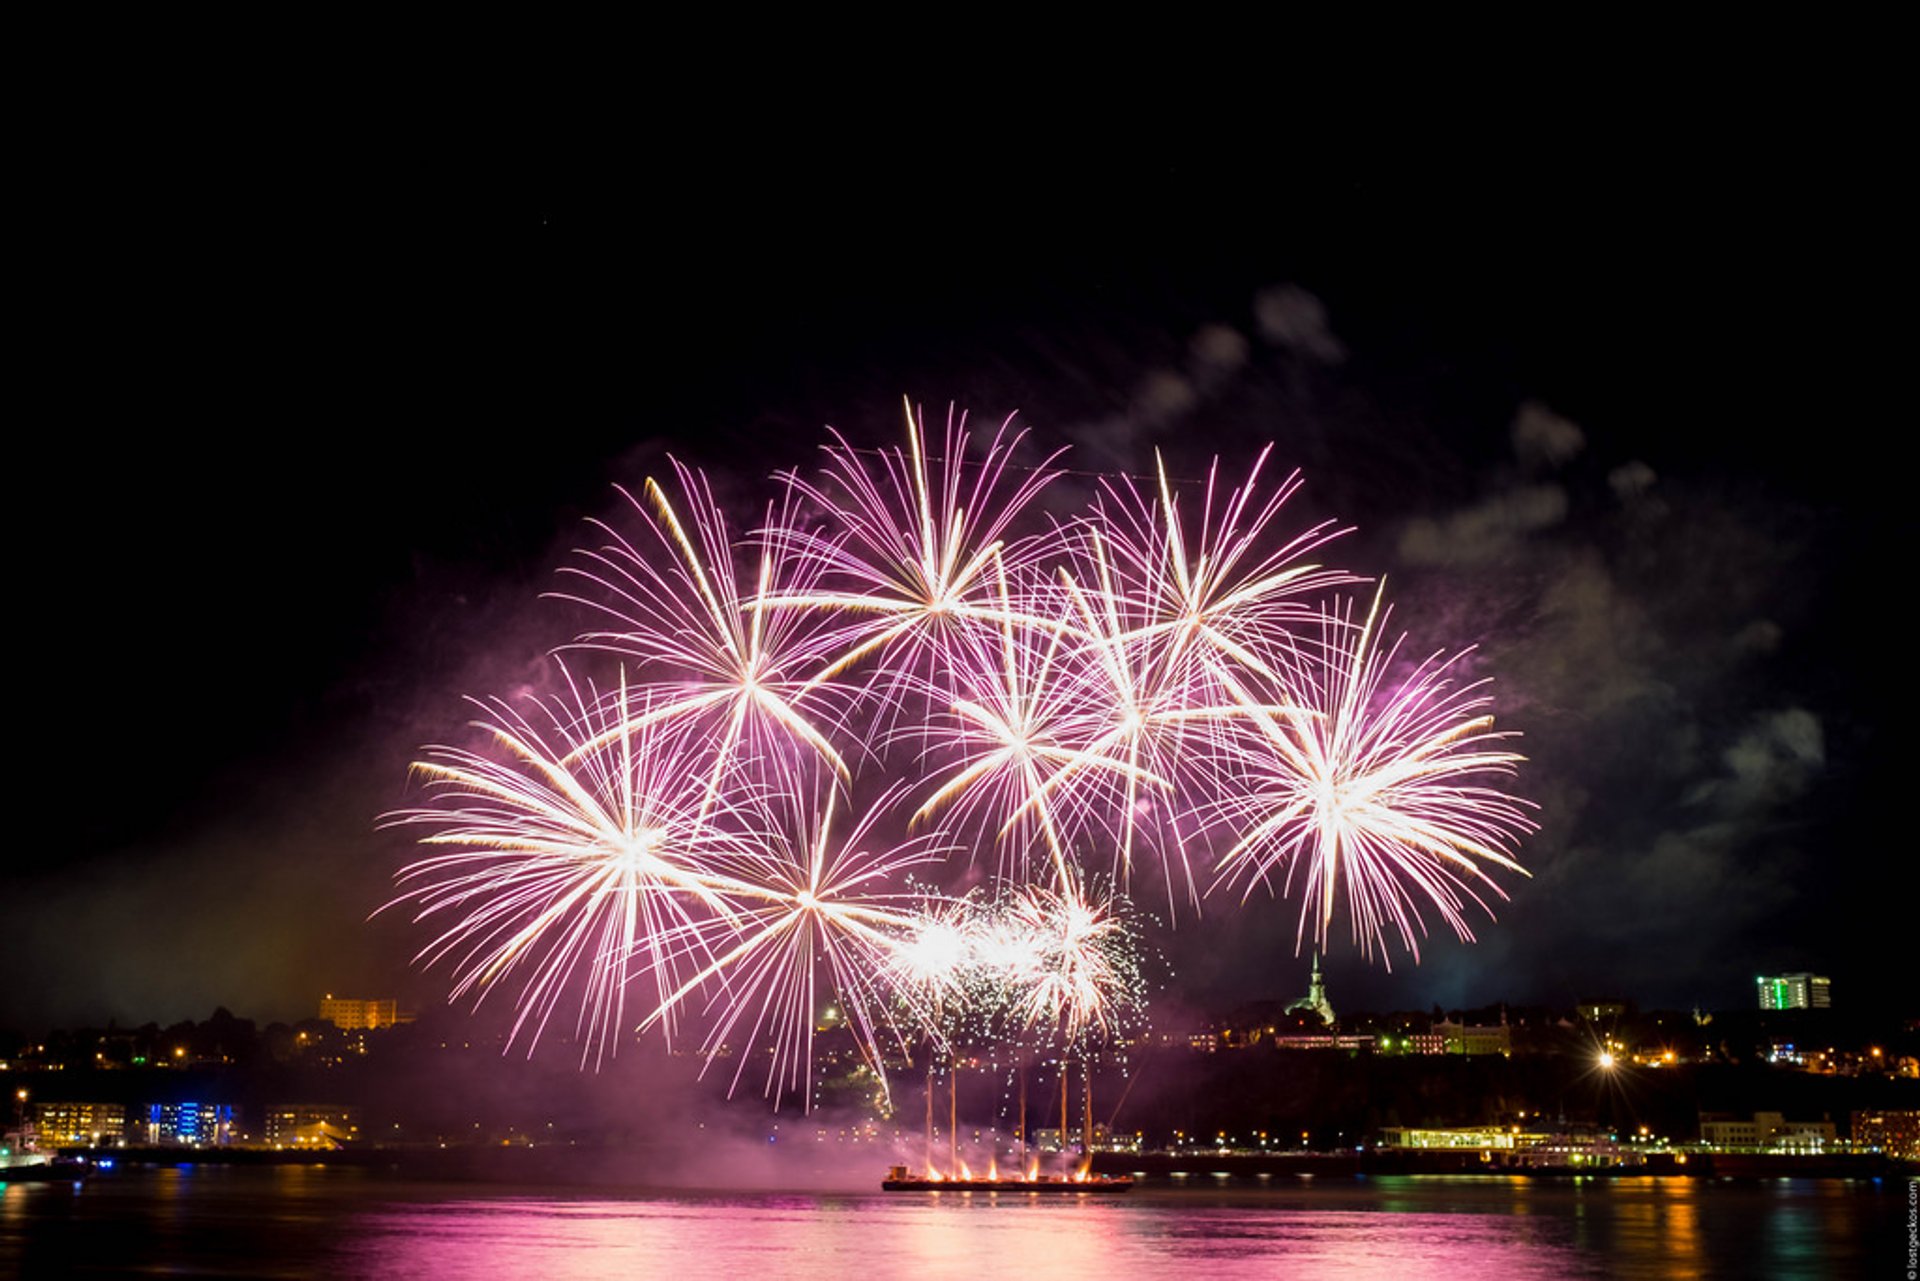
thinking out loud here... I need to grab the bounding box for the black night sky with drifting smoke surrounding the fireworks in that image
[11,65,1912,1029]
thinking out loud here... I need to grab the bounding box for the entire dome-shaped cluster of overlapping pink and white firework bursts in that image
[390,407,1532,1106]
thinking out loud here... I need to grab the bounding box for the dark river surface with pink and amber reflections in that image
[0,1166,1905,1281]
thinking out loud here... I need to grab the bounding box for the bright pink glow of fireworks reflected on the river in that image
[351,1193,1597,1281]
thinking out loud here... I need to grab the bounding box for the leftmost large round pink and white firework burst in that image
[386,666,771,1062]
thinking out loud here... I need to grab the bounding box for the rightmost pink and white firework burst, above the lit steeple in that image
[1212,593,1534,960]
